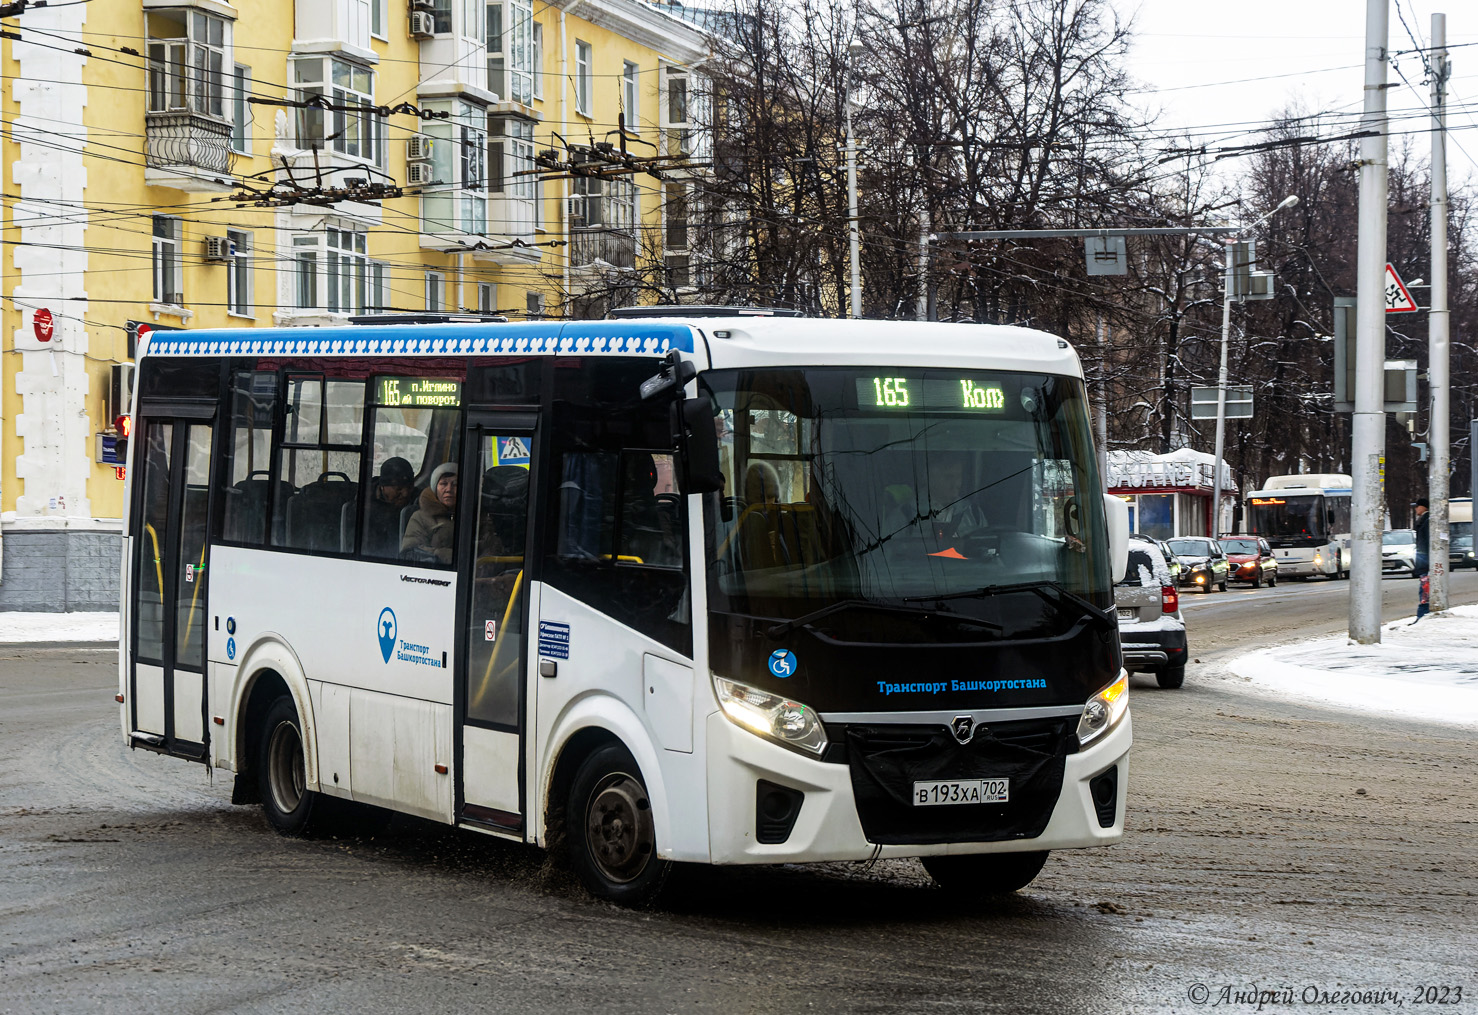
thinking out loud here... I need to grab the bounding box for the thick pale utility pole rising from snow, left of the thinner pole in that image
[1349,0,1389,646]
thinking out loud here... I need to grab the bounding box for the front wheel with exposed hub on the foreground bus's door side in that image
[566,743,672,907]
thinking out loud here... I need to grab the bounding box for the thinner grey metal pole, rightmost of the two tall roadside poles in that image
[1426,15,1451,613]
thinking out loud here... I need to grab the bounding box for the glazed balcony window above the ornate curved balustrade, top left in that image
[146,10,229,118]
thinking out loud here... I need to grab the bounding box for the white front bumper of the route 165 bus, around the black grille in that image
[708,712,1134,864]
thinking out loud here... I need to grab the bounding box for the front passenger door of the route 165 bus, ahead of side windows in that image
[457,412,535,835]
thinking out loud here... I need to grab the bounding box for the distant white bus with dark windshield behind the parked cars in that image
[1246,474,1354,578]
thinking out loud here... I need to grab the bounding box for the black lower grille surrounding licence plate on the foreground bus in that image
[844,717,1077,845]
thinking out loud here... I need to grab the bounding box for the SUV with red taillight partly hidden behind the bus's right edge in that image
[1113,538,1185,687]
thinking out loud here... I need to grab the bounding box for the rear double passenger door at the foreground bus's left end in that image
[129,409,213,759]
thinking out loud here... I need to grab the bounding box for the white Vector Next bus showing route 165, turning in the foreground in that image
[118,316,1131,904]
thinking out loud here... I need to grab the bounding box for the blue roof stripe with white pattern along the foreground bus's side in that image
[139,321,693,356]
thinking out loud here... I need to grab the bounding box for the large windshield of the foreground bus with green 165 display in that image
[705,368,1111,619]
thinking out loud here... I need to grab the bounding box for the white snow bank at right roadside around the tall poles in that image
[1228,606,1478,727]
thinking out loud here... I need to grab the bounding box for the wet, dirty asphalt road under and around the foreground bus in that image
[0,573,1478,1014]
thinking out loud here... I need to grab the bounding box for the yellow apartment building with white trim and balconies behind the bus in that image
[0,0,709,610]
